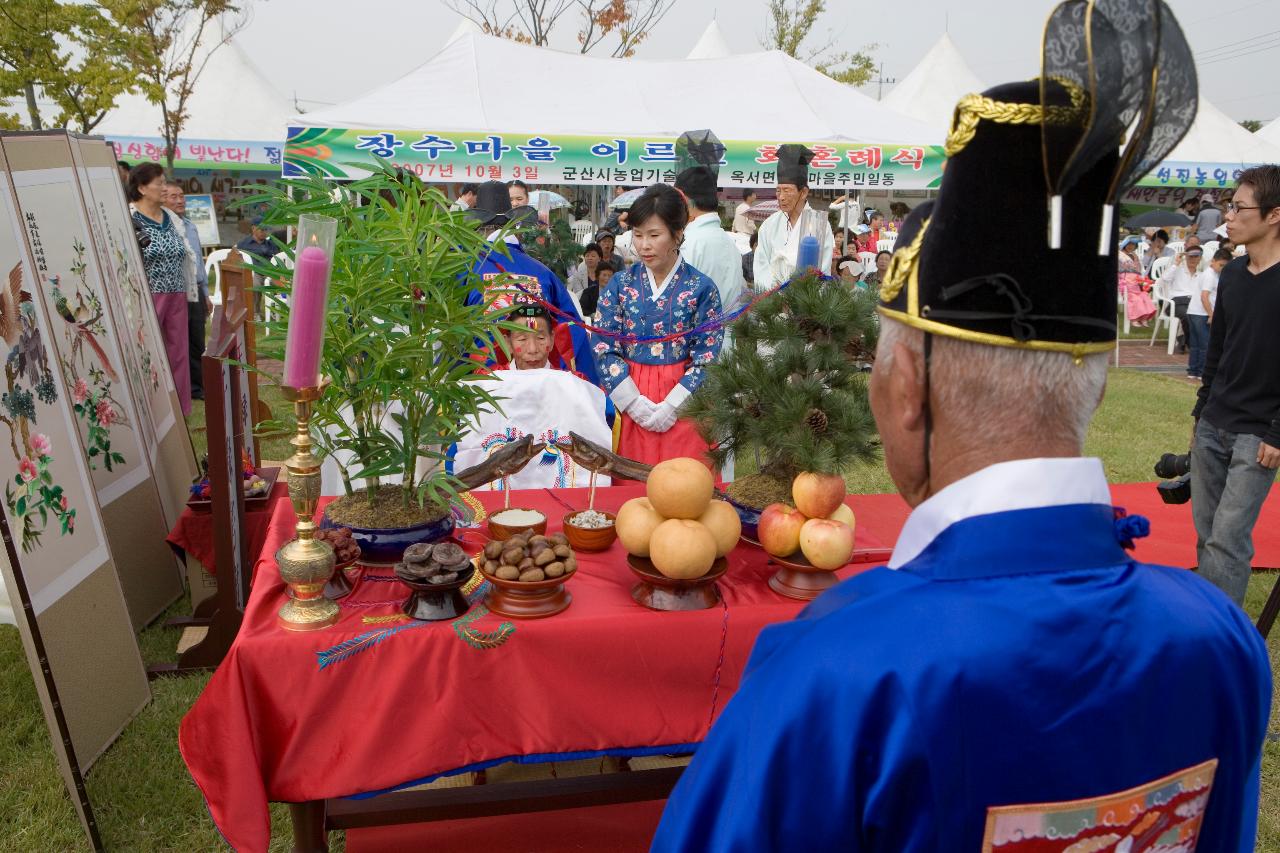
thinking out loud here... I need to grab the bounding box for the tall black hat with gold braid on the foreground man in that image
[879,0,1194,357]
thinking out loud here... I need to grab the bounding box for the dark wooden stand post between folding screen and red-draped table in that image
[147,313,251,679]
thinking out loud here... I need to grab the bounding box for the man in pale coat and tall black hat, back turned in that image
[676,131,744,318]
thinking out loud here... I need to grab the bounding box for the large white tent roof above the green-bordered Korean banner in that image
[296,33,943,145]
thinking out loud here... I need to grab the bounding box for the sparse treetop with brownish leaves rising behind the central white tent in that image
[443,0,676,56]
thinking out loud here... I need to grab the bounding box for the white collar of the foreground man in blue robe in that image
[888,456,1111,569]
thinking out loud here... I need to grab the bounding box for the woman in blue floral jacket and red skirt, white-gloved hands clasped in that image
[591,183,724,465]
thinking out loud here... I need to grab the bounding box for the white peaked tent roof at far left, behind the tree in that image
[93,22,294,169]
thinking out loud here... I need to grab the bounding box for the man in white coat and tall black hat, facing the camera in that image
[755,145,836,291]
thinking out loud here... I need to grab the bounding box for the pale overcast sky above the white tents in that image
[238,0,1280,122]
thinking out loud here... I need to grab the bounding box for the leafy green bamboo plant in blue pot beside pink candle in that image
[242,162,522,512]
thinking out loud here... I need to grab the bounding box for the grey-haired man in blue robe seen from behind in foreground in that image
[653,10,1271,853]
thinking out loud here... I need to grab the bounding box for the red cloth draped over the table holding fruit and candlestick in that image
[178,485,906,850]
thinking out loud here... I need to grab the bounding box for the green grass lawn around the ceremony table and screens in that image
[0,370,1280,853]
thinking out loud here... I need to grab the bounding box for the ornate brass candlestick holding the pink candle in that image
[275,384,339,631]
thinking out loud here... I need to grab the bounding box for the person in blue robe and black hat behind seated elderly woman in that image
[466,181,599,384]
